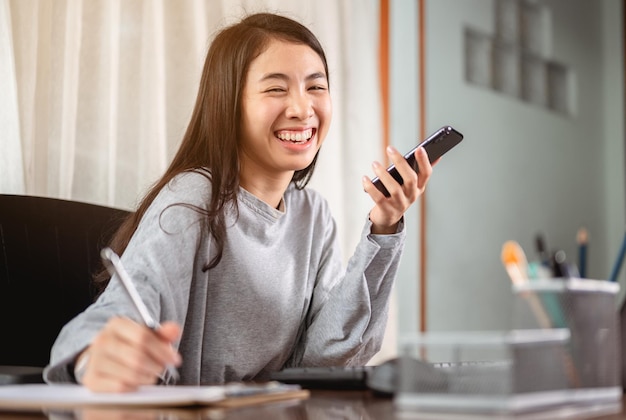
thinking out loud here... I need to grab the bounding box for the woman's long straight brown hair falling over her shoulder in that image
[95,13,328,292]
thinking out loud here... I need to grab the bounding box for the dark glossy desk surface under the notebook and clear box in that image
[0,391,626,420]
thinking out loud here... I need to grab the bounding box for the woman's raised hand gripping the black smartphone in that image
[363,146,437,234]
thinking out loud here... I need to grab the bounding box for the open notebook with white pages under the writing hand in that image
[0,382,309,410]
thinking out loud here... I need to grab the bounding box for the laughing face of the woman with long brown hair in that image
[240,40,332,179]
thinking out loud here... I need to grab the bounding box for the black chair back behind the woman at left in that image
[0,194,129,384]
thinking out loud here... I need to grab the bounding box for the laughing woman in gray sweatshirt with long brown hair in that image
[45,13,432,392]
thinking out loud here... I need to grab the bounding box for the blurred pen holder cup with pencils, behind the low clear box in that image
[513,278,622,401]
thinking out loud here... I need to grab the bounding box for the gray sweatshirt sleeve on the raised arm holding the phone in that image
[291,213,406,366]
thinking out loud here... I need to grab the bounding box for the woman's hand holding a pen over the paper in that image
[76,317,181,392]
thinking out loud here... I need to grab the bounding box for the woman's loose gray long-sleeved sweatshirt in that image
[44,172,405,385]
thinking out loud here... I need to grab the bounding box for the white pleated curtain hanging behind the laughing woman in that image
[0,0,395,360]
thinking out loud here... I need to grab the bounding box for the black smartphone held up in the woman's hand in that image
[372,126,463,197]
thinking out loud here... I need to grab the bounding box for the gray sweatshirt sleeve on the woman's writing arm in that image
[44,174,210,382]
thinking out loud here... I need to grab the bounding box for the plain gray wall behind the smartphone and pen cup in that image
[390,0,626,334]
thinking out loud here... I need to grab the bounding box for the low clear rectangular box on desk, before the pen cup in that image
[394,329,570,414]
